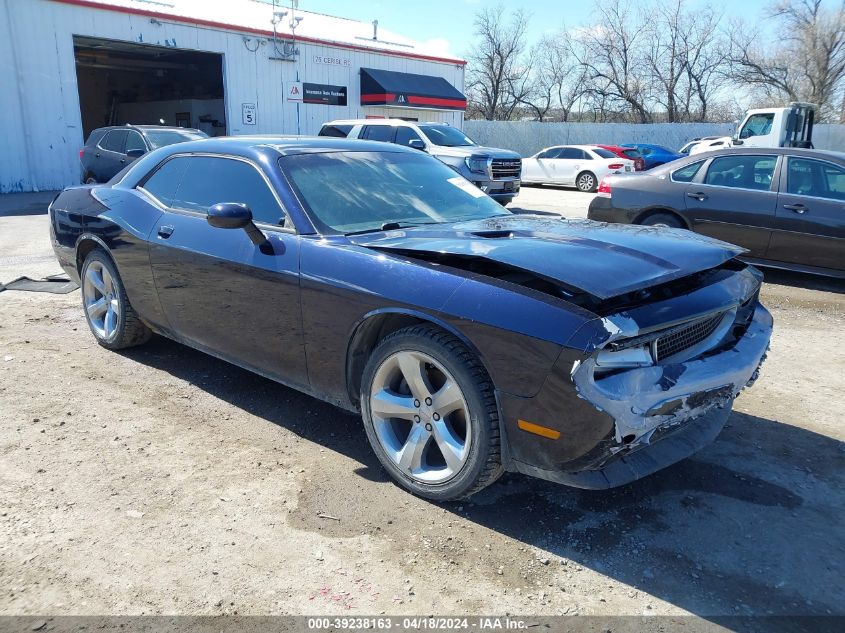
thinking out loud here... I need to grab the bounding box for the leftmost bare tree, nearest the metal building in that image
[467,6,533,121]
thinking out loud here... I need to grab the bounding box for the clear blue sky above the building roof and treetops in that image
[300,0,771,57]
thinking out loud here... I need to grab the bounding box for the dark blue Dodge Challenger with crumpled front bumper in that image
[50,137,772,500]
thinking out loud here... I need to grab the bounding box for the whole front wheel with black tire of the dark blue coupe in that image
[361,325,503,501]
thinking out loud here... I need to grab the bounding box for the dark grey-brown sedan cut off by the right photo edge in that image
[589,148,845,277]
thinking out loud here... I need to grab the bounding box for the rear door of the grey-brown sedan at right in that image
[684,154,778,257]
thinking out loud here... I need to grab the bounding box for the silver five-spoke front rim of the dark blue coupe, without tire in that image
[370,350,472,484]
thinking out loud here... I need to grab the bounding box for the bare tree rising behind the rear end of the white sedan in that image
[574,0,652,123]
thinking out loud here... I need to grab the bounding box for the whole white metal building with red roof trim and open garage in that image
[0,0,466,193]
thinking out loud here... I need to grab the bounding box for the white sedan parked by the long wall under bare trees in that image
[522,145,634,192]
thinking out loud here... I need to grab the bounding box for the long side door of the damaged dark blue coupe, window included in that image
[142,155,307,385]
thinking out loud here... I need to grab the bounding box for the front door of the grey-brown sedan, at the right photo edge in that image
[766,156,845,270]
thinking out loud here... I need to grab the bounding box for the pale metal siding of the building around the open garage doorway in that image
[0,0,464,193]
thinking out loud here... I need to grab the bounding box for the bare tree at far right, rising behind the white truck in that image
[730,0,845,116]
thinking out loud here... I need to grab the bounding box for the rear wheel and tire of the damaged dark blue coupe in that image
[81,249,152,350]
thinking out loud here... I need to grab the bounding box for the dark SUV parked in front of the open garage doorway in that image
[79,125,208,184]
